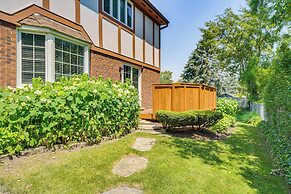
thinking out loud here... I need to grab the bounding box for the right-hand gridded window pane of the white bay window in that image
[55,38,84,80]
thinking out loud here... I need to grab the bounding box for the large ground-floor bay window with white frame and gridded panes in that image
[17,29,89,87]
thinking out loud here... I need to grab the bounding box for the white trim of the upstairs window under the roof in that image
[102,0,134,29]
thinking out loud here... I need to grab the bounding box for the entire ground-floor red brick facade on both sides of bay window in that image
[0,20,160,109]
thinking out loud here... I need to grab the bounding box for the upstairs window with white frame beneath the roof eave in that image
[103,0,133,28]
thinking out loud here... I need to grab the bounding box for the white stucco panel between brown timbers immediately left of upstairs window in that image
[80,0,99,46]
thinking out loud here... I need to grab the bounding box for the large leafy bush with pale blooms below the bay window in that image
[0,75,140,154]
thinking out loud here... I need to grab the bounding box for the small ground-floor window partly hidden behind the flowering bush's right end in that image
[123,65,140,91]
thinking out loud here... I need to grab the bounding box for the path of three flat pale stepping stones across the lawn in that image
[103,138,156,194]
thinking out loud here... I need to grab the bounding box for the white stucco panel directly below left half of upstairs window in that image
[102,19,118,52]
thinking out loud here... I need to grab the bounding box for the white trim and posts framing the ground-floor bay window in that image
[16,26,90,88]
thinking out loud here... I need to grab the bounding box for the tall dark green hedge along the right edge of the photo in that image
[260,41,291,185]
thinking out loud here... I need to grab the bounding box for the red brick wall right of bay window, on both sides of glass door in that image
[90,51,160,109]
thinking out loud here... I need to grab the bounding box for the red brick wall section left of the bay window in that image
[0,20,17,87]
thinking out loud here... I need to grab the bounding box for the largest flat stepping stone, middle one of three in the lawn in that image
[112,155,148,177]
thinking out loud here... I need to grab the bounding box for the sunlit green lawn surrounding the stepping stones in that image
[0,124,288,194]
